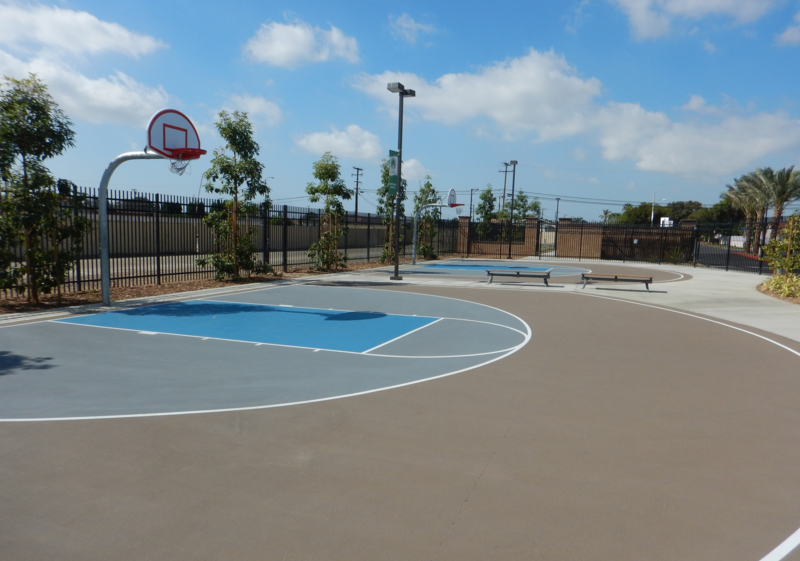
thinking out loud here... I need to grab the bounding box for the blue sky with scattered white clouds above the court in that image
[0,0,800,220]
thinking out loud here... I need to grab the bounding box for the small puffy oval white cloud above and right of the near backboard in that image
[245,20,358,68]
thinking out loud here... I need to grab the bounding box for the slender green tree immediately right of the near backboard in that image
[197,111,271,280]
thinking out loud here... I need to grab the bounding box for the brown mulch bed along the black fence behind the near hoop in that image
[0,259,422,314]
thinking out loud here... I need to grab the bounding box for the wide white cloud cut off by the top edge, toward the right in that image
[608,0,780,39]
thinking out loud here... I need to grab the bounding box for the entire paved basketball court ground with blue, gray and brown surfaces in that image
[0,261,800,561]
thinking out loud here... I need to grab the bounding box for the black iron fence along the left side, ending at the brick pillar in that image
[0,187,458,298]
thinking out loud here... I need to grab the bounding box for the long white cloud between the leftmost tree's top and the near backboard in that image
[0,51,169,127]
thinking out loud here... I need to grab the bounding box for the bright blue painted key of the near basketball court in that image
[58,300,439,353]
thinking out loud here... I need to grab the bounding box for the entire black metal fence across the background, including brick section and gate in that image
[0,188,788,298]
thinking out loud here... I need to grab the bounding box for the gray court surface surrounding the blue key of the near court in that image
[0,285,530,420]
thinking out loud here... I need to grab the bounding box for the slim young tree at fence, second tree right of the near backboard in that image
[306,152,353,271]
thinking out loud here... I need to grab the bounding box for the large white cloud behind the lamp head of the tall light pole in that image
[355,50,600,139]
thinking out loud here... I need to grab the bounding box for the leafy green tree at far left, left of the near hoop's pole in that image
[0,74,89,302]
